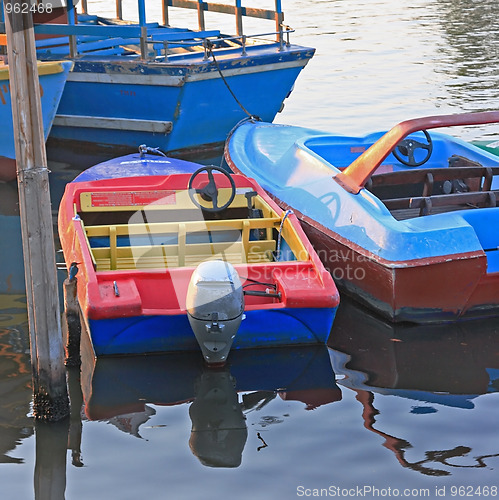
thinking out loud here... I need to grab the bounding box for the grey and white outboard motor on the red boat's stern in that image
[186,260,244,365]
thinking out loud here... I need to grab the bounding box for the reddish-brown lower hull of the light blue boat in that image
[300,216,499,323]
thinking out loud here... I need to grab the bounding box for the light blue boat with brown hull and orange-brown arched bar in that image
[225,111,499,323]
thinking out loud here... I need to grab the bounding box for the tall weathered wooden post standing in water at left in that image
[4,0,69,421]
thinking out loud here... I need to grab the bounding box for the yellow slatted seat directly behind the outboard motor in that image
[85,217,286,271]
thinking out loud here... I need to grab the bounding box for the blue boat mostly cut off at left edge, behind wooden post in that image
[0,61,73,182]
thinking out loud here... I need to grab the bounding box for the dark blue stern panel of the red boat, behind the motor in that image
[87,308,337,357]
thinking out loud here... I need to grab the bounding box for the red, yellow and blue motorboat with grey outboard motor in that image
[58,148,339,363]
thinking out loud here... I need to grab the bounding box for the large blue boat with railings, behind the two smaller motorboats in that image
[0,0,314,158]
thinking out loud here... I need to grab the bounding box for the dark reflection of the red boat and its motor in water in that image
[78,346,341,467]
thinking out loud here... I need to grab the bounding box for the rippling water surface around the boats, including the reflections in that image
[0,0,499,500]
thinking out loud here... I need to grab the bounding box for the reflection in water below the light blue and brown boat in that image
[329,299,499,476]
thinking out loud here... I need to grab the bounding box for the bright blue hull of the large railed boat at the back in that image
[50,44,314,155]
